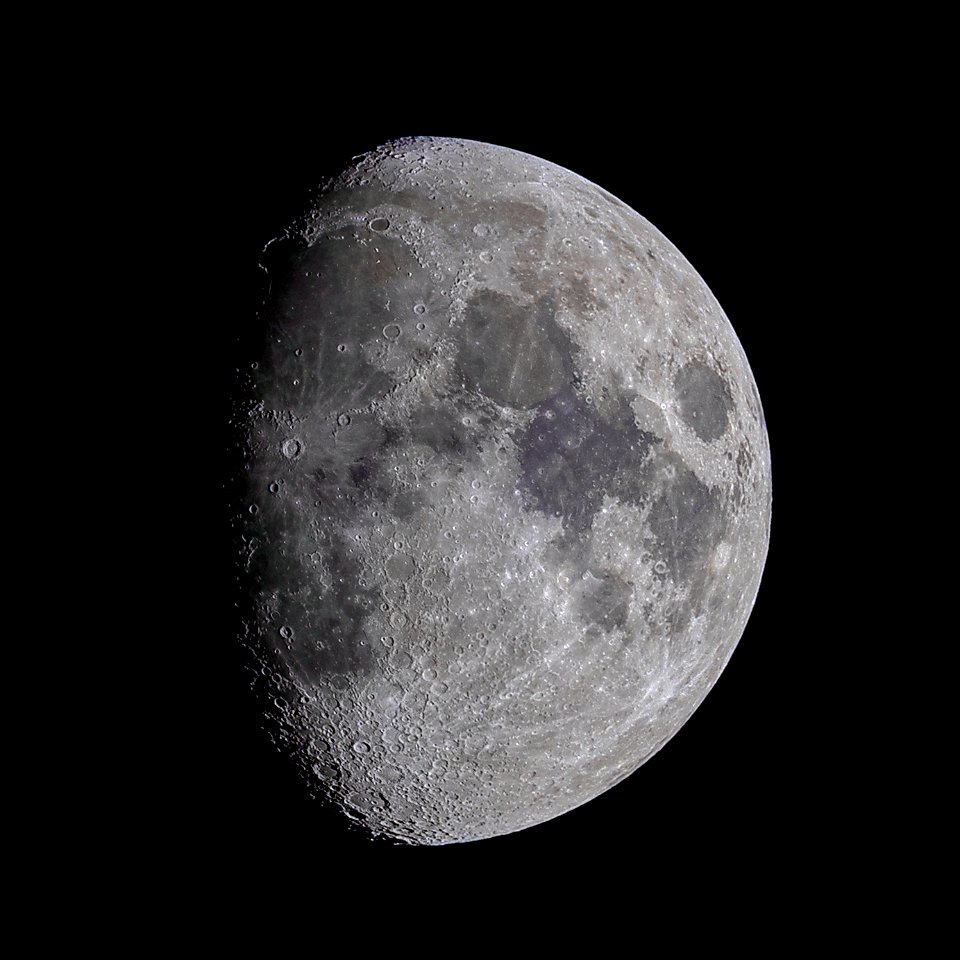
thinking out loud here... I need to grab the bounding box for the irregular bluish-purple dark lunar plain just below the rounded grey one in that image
[517,386,658,537]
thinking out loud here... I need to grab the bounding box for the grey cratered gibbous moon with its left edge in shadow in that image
[231,137,771,845]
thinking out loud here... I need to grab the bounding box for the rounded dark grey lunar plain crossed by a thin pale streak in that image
[457,290,573,409]
